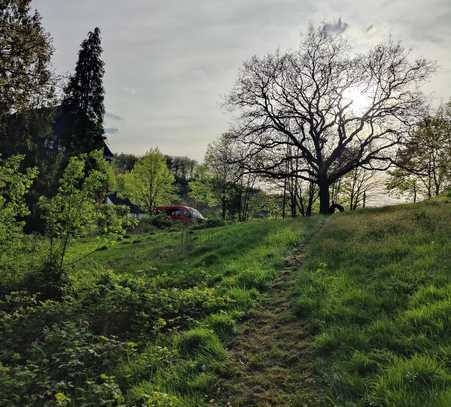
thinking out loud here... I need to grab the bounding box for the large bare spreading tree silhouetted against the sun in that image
[226,27,434,213]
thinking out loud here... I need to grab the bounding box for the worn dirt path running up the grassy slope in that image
[210,228,319,407]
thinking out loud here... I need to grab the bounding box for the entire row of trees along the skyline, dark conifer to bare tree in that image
[0,0,451,242]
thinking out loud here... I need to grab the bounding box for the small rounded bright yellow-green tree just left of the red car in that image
[123,148,174,211]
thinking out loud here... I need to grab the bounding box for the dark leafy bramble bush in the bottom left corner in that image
[0,321,131,407]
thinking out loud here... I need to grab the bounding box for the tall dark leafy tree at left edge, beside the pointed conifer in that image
[0,0,58,207]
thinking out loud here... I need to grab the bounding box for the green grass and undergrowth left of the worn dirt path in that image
[0,219,318,407]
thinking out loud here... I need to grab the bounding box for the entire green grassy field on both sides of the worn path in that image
[0,199,451,407]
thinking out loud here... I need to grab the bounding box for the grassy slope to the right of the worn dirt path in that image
[296,200,451,407]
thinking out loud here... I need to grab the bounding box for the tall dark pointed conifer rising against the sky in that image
[57,28,105,155]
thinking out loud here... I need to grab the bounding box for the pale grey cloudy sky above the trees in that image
[32,0,451,161]
